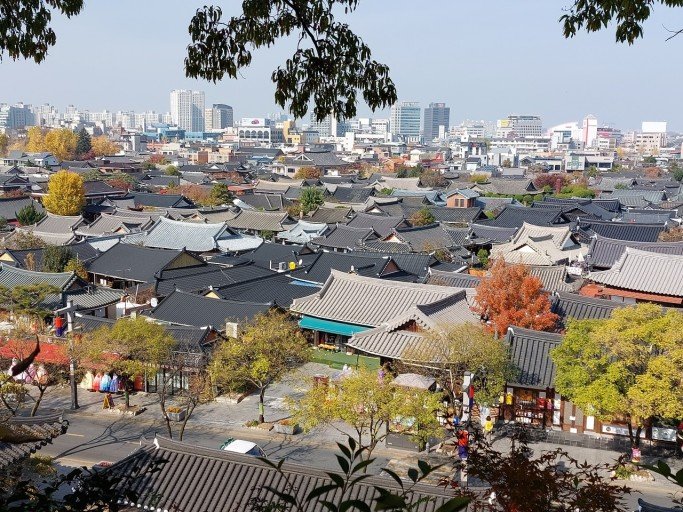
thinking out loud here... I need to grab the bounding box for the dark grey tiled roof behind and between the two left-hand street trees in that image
[149,290,271,331]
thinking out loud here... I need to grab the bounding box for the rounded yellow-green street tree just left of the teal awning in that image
[210,310,309,423]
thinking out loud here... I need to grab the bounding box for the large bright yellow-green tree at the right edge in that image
[551,304,683,446]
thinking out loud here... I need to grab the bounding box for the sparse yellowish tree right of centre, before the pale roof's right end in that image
[401,324,511,404]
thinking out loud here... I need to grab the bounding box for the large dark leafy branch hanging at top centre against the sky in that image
[185,0,397,120]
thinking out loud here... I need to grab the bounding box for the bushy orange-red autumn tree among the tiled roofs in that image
[475,259,558,336]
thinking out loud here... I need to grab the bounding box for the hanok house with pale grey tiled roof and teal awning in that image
[290,270,465,364]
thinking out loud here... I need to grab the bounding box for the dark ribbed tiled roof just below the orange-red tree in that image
[506,327,562,389]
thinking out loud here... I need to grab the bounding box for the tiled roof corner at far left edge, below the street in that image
[0,413,69,469]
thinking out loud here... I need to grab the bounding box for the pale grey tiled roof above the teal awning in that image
[291,270,468,327]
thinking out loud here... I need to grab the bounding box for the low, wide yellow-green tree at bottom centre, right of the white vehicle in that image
[292,368,441,458]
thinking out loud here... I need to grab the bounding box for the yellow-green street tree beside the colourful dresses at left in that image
[87,316,177,407]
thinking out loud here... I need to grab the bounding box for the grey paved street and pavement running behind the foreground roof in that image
[21,365,680,510]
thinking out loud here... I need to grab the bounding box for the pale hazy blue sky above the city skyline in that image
[0,0,683,130]
